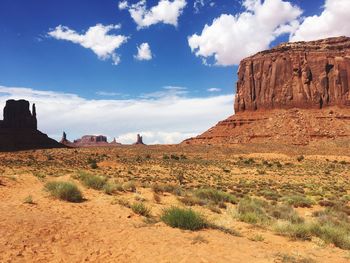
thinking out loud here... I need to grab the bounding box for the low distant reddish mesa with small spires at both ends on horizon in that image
[60,132,121,147]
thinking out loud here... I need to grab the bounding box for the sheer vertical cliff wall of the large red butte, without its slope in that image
[234,37,350,113]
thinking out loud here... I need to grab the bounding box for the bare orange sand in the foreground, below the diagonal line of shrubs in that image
[0,174,350,263]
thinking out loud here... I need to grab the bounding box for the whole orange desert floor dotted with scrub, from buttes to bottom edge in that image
[0,141,350,263]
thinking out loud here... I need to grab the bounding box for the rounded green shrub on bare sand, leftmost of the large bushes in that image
[44,182,83,203]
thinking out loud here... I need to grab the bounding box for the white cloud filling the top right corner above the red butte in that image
[290,0,350,41]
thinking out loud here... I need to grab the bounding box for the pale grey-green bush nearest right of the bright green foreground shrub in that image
[237,198,269,225]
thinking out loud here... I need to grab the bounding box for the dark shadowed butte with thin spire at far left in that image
[0,100,64,151]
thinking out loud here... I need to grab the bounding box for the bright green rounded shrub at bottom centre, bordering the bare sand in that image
[161,207,208,230]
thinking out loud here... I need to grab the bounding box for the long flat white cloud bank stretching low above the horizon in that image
[0,86,233,144]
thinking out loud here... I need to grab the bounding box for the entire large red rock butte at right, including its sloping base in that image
[183,37,350,144]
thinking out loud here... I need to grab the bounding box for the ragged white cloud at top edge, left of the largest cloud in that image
[119,0,187,29]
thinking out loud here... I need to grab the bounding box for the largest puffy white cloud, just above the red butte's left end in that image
[188,0,302,66]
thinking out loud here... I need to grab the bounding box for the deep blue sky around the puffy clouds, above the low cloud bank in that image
[0,0,322,98]
